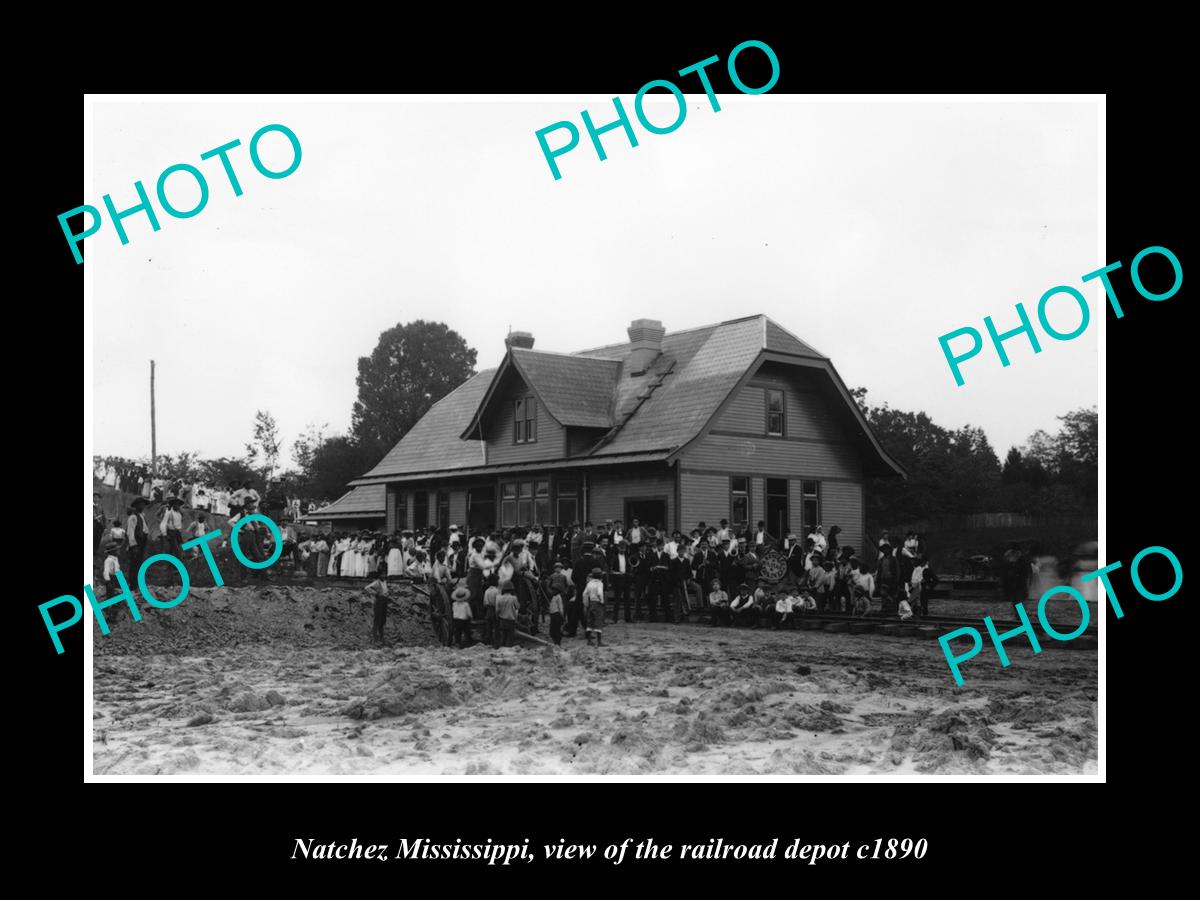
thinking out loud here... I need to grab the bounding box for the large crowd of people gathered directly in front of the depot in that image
[304,520,936,647]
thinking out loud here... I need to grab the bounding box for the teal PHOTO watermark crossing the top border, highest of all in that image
[534,41,779,181]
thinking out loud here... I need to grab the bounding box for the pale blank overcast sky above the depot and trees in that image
[85,95,1109,472]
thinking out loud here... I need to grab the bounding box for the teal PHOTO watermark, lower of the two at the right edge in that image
[937,546,1183,686]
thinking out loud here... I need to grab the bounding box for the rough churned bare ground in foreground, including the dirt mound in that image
[94,588,1097,778]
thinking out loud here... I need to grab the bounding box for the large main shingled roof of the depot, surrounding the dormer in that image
[352,316,904,484]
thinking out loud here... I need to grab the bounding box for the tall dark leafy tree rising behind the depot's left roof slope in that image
[350,319,475,460]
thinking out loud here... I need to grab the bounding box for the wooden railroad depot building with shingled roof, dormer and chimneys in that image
[343,316,905,547]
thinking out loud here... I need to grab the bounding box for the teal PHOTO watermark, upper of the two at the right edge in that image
[937,247,1183,388]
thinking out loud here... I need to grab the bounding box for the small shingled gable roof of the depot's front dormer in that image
[461,347,620,439]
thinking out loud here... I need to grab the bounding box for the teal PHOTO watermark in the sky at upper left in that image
[59,125,301,264]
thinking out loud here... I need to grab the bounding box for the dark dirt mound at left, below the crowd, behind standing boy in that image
[92,584,437,655]
